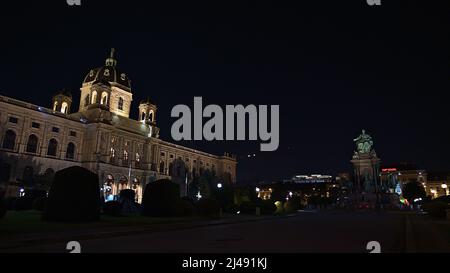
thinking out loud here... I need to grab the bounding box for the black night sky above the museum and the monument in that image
[0,0,450,180]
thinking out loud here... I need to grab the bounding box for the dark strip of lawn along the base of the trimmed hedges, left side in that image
[0,211,209,238]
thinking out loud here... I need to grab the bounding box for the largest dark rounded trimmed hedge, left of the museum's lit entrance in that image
[42,166,100,222]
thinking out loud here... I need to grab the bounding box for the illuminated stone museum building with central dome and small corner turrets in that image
[0,51,236,200]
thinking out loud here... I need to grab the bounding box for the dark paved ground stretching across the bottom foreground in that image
[2,212,450,253]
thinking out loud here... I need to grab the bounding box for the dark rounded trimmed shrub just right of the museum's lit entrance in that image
[142,179,180,217]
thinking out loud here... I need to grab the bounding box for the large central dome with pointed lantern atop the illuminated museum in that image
[83,48,131,91]
